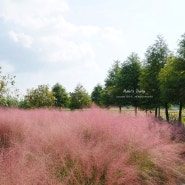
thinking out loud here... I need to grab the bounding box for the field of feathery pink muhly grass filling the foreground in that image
[0,108,185,185]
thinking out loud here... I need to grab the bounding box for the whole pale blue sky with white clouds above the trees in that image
[0,0,185,94]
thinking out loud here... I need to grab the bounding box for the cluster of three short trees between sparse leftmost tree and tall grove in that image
[19,83,91,109]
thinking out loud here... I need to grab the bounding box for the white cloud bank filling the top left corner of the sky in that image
[0,0,69,29]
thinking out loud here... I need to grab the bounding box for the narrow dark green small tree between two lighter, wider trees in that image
[52,83,69,108]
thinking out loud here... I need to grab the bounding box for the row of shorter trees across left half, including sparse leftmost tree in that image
[0,67,92,109]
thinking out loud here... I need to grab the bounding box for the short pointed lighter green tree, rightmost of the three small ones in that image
[70,84,91,109]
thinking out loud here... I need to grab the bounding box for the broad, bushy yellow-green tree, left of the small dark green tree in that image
[25,85,55,108]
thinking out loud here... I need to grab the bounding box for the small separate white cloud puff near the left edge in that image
[8,31,33,48]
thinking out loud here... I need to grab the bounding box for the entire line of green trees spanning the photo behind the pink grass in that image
[0,34,185,122]
